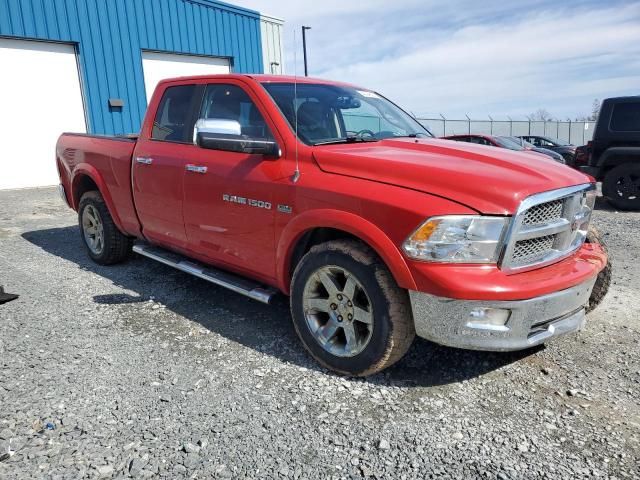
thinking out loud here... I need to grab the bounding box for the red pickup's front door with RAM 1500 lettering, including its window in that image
[184,80,282,281]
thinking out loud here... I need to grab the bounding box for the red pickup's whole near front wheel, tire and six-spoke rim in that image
[291,240,415,376]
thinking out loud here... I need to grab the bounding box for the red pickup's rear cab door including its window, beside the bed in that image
[133,85,202,249]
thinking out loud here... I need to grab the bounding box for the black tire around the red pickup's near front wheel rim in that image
[291,240,415,377]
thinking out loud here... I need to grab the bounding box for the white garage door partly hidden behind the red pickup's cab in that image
[142,52,231,103]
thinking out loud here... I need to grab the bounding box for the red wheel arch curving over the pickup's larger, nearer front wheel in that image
[276,209,416,294]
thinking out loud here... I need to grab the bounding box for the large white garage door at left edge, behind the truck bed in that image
[0,38,86,189]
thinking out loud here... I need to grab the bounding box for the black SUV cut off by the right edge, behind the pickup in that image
[573,96,640,210]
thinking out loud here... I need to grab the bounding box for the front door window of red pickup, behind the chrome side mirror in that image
[199,84,273,140]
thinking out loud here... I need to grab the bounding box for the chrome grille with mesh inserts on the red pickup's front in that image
[500,185,593,271]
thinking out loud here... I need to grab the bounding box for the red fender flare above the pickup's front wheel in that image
[276,209,416,295]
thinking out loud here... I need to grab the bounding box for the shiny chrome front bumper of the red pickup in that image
[409,277,596,351]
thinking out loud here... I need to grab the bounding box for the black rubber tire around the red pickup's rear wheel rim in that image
[78,191,133,265]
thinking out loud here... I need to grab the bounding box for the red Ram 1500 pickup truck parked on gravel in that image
[56,75,607,375]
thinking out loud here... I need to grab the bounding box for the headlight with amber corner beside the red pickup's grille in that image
[402,215,509,263]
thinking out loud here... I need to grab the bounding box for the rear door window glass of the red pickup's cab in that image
[151,85,196,142]
